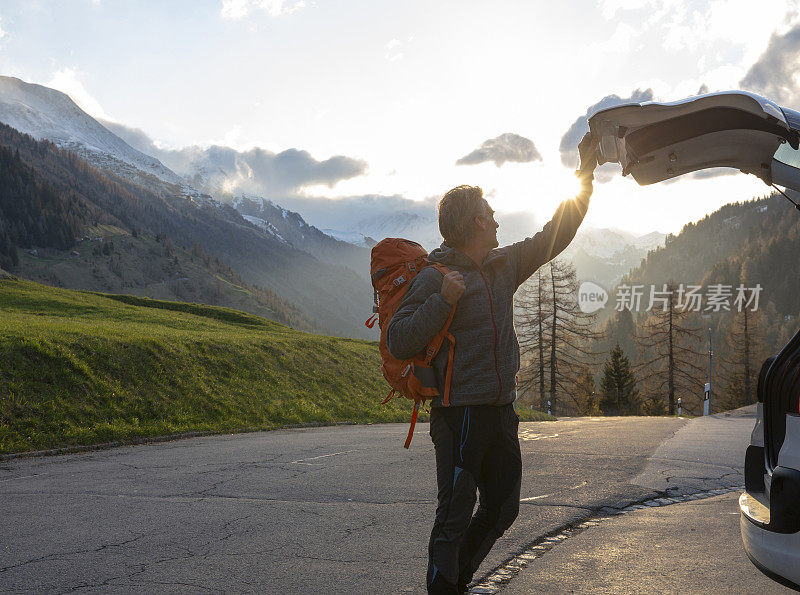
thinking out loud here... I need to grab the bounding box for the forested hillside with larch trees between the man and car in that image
[516,194,800,415]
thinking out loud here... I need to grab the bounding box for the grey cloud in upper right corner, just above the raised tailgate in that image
[739,24,800,109]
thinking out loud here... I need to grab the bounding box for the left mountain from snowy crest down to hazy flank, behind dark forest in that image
[0,77,373,338]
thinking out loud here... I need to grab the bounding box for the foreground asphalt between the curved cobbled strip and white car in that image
[502,491,793,595]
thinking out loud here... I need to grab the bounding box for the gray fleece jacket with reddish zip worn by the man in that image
[386,180,592,407]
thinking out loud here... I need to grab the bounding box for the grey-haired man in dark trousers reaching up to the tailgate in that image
[387,134,597,593]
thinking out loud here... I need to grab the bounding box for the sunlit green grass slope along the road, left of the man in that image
[0,279,548,453]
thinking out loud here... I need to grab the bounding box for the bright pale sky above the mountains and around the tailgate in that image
[0,0,800,234]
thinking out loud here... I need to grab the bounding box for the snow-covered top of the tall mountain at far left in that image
[0,76,183,184]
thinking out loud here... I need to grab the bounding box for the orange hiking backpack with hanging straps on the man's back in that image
[365,238,456,448]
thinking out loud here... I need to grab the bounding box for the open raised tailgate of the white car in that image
[589,91,800,191]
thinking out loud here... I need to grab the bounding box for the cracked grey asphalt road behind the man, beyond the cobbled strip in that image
[0,416,752,593]
